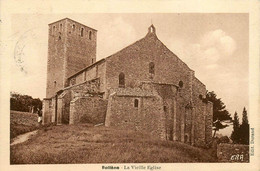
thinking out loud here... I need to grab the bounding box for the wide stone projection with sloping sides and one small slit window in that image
[105,89,166,139]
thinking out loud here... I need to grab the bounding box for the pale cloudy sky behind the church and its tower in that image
[9,13,249,135]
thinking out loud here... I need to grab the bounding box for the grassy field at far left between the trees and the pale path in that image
[10,111,38,139]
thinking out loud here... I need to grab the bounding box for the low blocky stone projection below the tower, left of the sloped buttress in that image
[70,97,107,124]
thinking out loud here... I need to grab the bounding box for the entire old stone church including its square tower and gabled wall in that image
[43,18,213,146]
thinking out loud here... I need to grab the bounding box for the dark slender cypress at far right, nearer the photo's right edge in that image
[239,107,249,145]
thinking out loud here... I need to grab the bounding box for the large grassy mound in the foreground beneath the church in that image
[11,125,215,164]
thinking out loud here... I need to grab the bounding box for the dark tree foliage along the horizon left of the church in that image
[10,92,42,112]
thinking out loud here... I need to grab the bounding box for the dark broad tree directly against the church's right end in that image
[205,91,232,137]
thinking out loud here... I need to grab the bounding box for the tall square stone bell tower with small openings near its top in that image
[46,18,97,98]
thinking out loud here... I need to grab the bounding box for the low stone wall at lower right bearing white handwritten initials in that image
[217,144,249,163]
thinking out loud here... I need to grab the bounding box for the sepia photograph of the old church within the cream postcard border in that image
[10,13,251,164]
